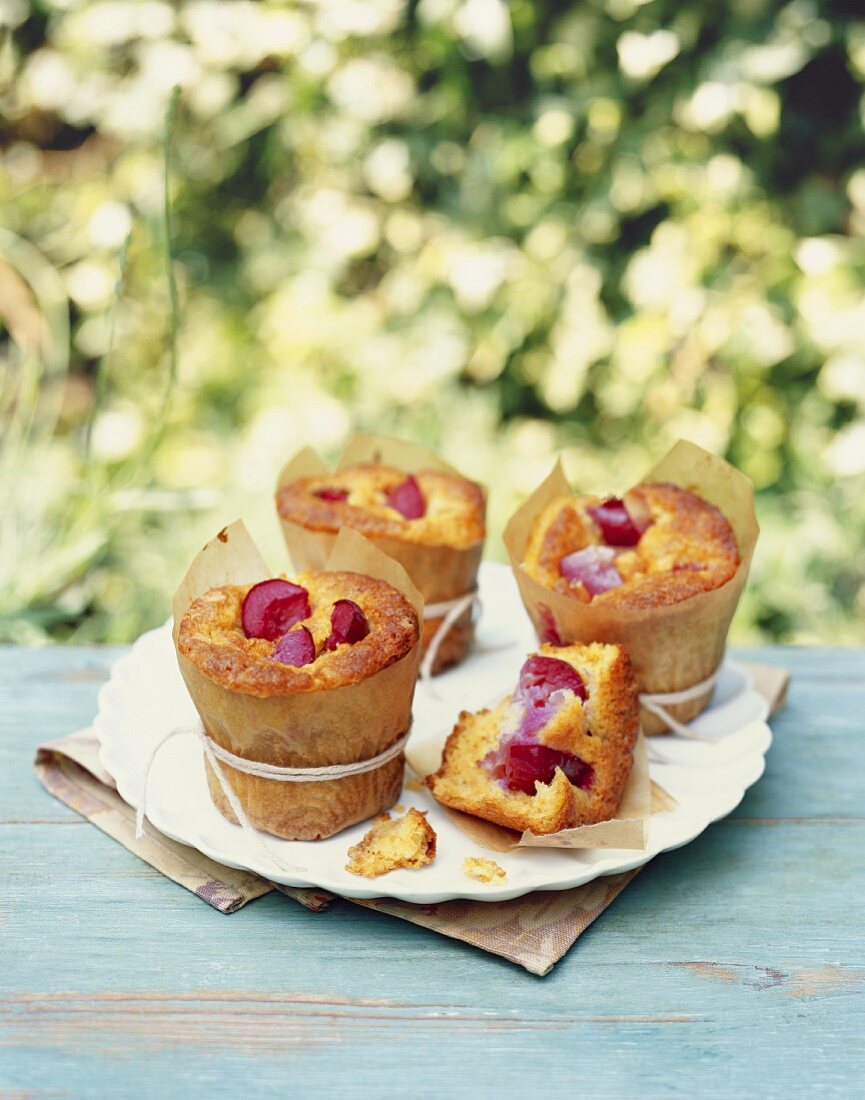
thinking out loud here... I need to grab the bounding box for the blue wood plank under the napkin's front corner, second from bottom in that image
[0,823,865,994]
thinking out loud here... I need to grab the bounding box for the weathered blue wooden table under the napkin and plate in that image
[0,648,865,1100]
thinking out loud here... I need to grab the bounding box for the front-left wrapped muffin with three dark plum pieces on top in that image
[175,528,419,840]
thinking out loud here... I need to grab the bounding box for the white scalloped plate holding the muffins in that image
[94,563,771,904]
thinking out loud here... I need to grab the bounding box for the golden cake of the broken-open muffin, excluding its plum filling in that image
[427,642,639,835]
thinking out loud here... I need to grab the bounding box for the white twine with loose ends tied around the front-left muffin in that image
[135,724,412,872]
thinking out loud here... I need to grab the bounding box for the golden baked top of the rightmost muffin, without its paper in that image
[523,482,740,611]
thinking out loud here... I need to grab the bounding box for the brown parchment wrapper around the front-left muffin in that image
[173,523,424,840]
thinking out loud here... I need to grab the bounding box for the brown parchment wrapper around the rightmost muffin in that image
[504,440,759,734]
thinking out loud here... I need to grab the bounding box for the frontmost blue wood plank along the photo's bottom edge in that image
[0,969,863,1098]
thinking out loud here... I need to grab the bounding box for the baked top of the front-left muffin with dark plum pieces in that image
[177,572,419,696]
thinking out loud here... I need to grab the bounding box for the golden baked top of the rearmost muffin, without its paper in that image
[276,463,485,550]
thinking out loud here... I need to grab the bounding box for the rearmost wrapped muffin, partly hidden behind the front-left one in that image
[276,433,485,674]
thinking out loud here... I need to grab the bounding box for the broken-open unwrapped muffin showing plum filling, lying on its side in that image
[427,644,639,835]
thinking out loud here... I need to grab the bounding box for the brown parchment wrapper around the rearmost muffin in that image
[276,435,483,673]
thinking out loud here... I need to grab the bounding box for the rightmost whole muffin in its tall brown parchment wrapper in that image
[505,441,758,734]
